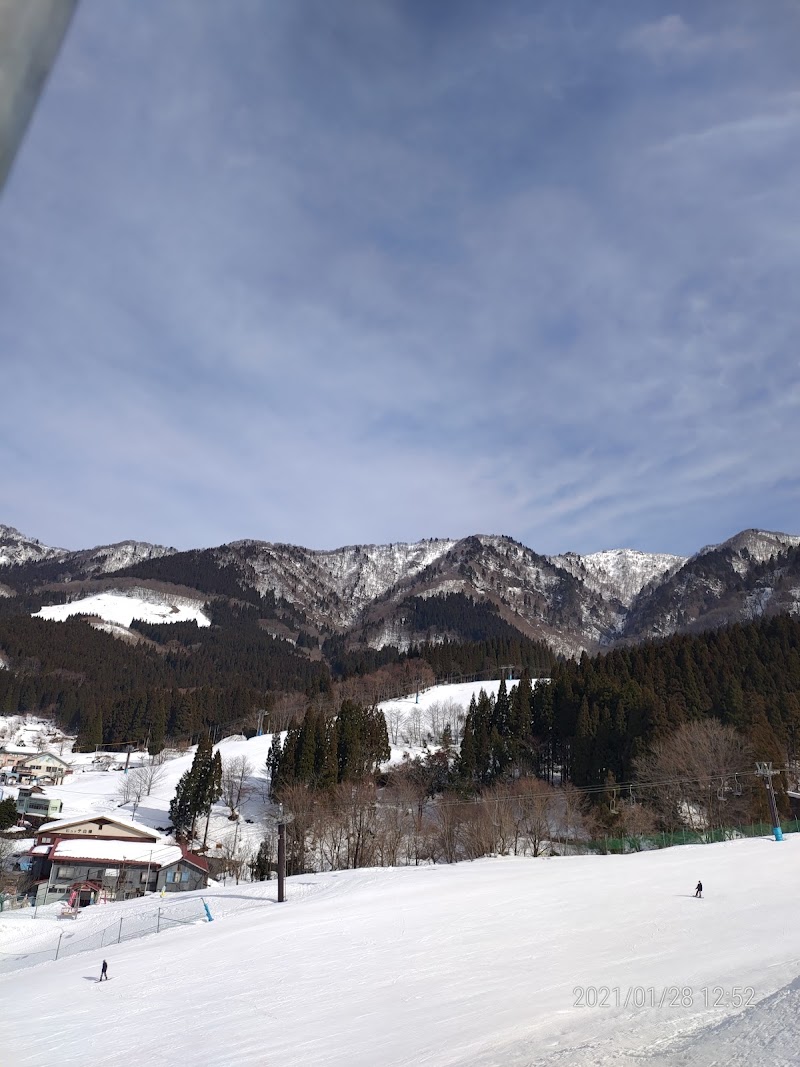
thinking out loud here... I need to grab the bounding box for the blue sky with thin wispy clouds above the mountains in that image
[0,0,800,554]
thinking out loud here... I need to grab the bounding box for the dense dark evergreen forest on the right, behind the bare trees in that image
[460,616,800,786]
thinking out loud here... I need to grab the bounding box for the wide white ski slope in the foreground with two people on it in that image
[0,838,800,1067]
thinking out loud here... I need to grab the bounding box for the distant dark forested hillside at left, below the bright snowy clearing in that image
[0,593,555,751]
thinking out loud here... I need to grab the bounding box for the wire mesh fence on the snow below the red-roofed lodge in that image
[0,897,207,973]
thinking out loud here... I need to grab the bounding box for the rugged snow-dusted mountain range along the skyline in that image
[0,525,800,656]
